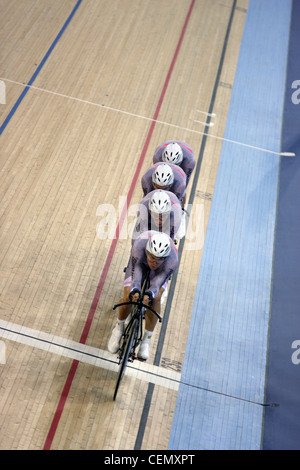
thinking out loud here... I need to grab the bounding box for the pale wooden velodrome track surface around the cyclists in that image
[0,0,248,450]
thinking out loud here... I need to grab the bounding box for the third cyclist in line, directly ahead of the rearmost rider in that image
[141,162,186,204]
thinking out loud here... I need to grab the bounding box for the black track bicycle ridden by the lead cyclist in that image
[113,269,162,400]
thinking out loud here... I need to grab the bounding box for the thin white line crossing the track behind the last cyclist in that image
[0,77,295,157]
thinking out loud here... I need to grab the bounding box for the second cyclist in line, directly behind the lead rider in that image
[132,189,182,241]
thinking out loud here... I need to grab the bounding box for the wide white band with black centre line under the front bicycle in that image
[0,320,181,390]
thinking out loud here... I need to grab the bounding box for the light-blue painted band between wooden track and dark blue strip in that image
[169,0,291,450]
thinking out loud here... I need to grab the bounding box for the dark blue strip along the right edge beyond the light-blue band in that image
[263,0,300,450]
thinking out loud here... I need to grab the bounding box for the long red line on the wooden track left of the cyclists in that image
[44,0,196,450]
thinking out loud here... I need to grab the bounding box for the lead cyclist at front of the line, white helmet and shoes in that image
[108,230,178,361]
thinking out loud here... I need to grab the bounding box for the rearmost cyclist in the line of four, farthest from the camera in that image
[153,140,196,185]
